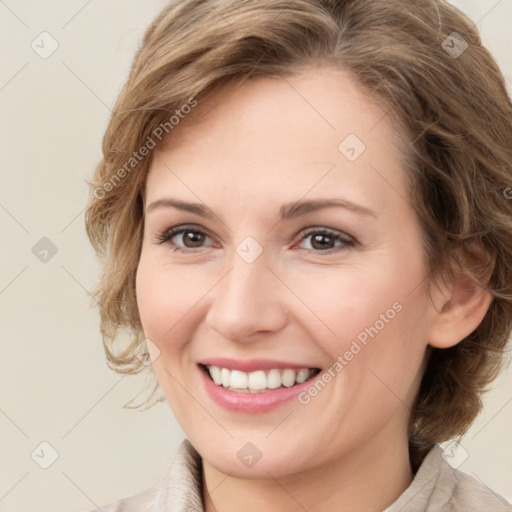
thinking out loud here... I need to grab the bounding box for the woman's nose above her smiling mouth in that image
[206,255,288,342]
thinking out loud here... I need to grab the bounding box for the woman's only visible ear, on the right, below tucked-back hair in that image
[429,246,492,348]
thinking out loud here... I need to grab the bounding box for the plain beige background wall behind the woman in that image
[0,0,512,512]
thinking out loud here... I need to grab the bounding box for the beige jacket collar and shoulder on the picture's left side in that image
[79,440,203,512]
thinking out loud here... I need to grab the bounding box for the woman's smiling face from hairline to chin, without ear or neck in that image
[137,69,440,478]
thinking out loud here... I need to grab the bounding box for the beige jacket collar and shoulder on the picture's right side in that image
[384,445,512,512]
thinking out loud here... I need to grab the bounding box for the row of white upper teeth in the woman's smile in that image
[206,366,316,393]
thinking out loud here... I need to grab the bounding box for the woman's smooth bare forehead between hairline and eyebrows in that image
[146,68,406,219]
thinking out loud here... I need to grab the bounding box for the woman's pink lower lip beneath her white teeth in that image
[199,367,320,413]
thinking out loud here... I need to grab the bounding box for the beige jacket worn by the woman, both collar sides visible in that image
[84,440,512,512]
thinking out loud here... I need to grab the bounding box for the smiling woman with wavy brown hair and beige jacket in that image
[86,0,512,512]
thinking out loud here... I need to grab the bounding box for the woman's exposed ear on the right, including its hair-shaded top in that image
[428,245,492,348]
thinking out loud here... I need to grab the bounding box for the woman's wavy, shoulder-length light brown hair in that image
[85,0,512,466]
